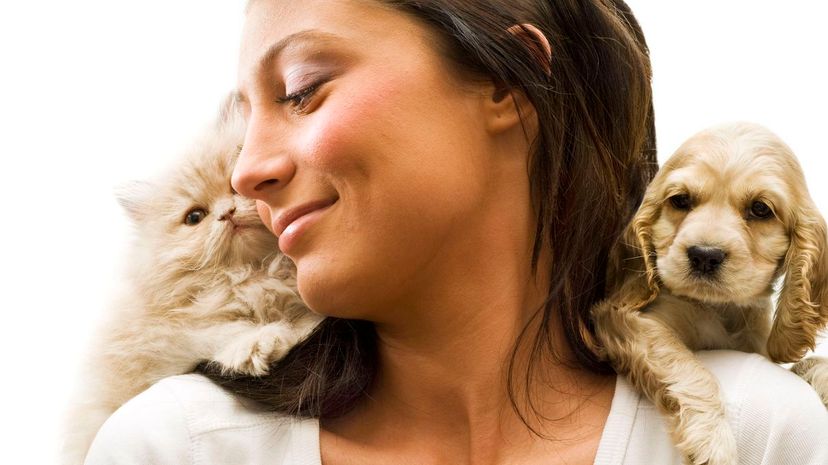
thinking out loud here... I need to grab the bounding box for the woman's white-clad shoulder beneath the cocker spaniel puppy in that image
[608,350,828,465]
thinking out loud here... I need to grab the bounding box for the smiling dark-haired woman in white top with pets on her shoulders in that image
[87,0,828,465]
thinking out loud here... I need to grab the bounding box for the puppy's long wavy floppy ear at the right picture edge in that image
[767,203,828,363]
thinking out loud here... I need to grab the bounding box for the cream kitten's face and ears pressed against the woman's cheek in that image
[122,117,279,271]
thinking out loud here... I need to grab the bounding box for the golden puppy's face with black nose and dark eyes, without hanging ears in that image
[645,126,804,305]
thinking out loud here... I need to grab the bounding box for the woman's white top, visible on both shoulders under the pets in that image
[86,351,828,465]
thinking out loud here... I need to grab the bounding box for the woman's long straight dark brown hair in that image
[200,0,657,418]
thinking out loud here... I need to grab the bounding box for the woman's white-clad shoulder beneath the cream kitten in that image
[86,374,319,465]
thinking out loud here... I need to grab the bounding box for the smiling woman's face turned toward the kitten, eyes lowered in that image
[233,0,525,321]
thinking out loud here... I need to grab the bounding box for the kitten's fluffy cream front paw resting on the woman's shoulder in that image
[213,323,293,376]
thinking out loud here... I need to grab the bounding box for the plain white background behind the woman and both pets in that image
[0,0,828,464]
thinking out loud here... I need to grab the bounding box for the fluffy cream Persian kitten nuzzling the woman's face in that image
[62,99,321,465]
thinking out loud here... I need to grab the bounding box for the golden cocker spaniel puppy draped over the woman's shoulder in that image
[593,123,828,465]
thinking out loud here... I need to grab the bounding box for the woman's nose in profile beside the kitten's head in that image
[230,119,295,202]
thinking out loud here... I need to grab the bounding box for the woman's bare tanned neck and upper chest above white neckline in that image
[322,183,614,465]
